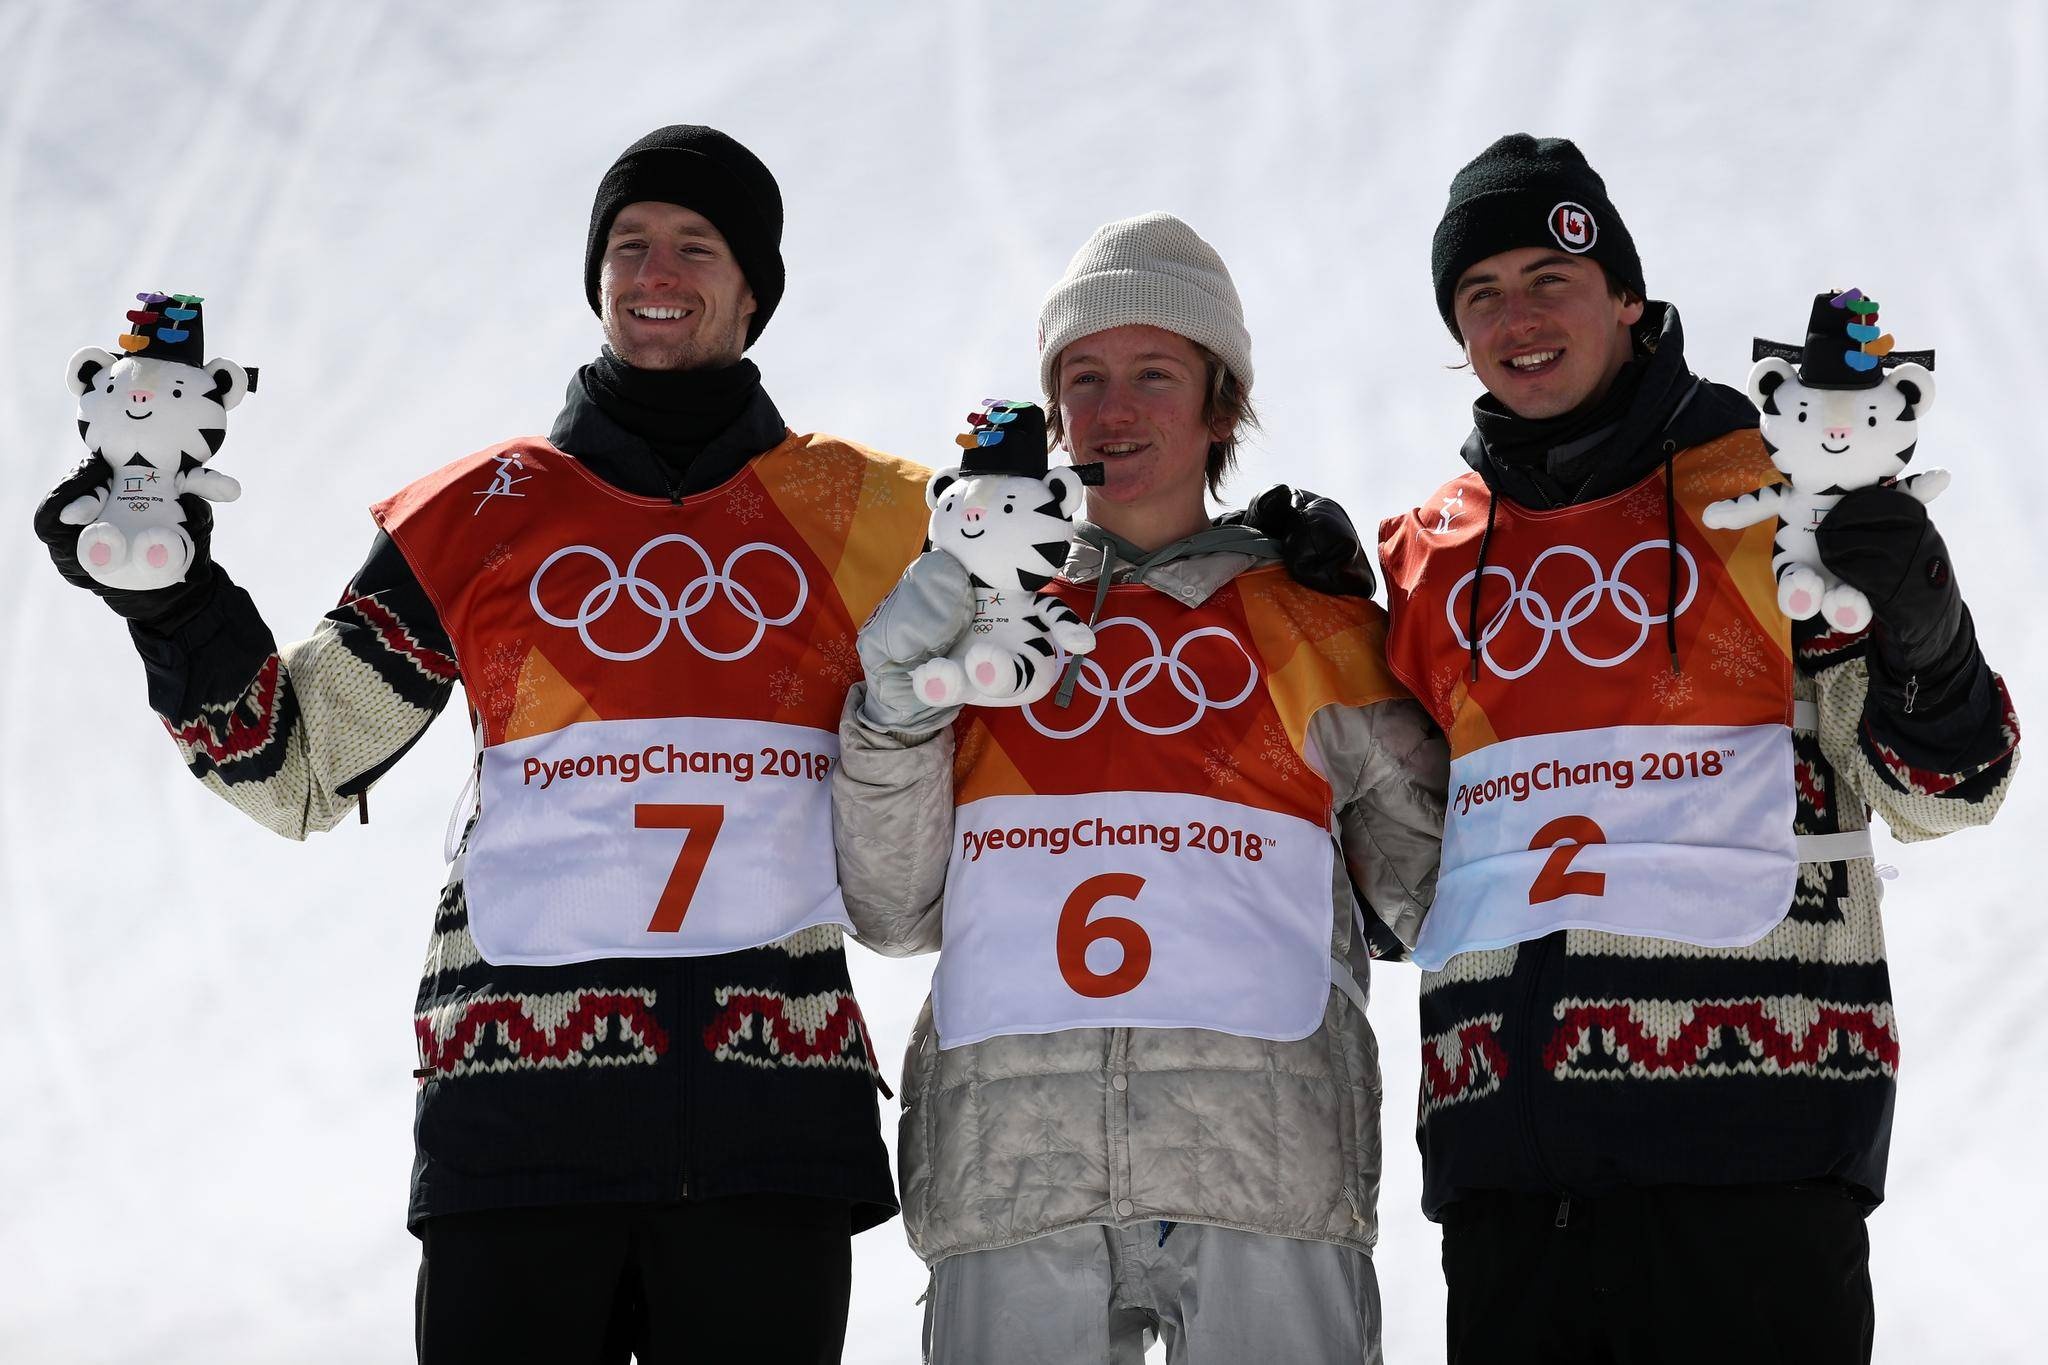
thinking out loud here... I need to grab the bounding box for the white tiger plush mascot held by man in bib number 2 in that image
[1704,289,1948,634]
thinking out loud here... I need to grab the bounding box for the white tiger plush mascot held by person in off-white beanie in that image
[909,401,1102,706]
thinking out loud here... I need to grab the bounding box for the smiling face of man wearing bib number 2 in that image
[1452,246,1642,417]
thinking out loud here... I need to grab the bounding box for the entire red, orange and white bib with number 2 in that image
[1380,432,1798,970]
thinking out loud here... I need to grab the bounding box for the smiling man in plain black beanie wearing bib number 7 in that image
[37,125,929,1365]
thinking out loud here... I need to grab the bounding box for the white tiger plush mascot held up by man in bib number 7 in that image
[59,293,256,589]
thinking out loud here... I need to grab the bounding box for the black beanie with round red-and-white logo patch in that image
[1430,133,1647,340]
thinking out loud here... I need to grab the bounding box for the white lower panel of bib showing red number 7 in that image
[465,716,852,966]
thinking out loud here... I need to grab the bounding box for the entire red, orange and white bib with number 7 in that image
[373,436,926,966]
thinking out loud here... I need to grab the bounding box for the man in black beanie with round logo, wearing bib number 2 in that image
[1380,135,2017,1365]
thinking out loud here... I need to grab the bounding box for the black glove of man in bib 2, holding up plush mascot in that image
[1812,487,1985,716]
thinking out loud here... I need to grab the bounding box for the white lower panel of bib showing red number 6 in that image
[932,792,1335,1048]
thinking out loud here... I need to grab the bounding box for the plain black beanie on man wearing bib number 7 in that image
[584,123,782,346]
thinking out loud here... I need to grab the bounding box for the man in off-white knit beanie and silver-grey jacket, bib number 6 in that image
[834,213,1448,1365]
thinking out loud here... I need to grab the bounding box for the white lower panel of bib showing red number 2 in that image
[1413,724,1798,972]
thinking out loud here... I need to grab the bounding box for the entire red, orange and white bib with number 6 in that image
[932,567,1403,1048]
